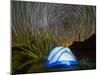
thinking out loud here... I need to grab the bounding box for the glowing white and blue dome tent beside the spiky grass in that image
[46,47,77,68]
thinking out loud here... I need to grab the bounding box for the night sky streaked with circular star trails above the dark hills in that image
[12,1,96,46]
